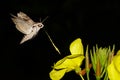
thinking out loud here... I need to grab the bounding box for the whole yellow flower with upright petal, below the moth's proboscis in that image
[49,38,84,80]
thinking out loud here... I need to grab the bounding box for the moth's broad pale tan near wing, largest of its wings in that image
[12,17,32,34]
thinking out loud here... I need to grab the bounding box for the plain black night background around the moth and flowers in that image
[0,0,120,80]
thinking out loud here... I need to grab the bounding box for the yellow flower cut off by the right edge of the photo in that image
[107,50,120,80]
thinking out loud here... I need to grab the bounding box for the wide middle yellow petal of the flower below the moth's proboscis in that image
[54,54,84,72]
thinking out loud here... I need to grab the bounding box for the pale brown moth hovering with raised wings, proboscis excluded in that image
[11,12,44,44]
